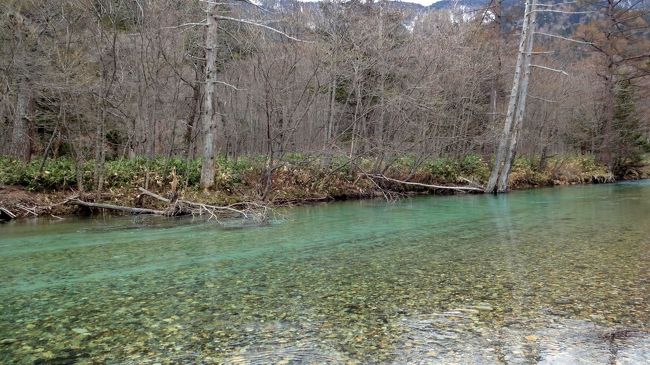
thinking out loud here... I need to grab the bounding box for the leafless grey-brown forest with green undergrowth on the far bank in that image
[0,0,650,200]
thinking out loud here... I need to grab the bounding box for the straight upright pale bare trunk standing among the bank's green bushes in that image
[201,3,217,189]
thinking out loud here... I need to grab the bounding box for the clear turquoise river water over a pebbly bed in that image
[0,181,650,364]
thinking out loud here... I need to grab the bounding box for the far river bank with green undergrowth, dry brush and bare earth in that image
[0,155,650,219]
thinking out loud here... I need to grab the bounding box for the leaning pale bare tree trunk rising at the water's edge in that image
[485,0,537,192]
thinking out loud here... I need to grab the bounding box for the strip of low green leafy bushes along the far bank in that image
[0,154,624,193]
